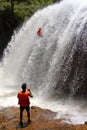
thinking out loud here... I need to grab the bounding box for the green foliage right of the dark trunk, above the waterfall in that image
[14,0,52,20]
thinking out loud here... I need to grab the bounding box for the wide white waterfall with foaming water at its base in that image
[0,0,87,124]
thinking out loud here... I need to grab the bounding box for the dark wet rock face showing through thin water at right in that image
[55,21,87,99]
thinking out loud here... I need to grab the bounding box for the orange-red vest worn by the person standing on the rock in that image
[18,91,30,106]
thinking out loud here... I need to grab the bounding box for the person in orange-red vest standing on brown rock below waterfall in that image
[17,83,33,125]
